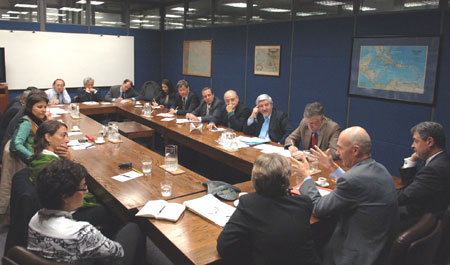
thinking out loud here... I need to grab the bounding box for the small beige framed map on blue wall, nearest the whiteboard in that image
[183,40,212,77]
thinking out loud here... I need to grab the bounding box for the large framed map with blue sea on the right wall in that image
[349,37,440,104]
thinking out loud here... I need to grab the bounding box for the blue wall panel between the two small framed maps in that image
[212,26,247,99]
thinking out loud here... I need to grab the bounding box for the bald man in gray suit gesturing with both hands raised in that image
[291,127,398,265]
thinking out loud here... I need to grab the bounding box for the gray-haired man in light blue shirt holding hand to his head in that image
[244,94,294,144]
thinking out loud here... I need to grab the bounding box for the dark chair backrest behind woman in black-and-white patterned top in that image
[2,246,68,265]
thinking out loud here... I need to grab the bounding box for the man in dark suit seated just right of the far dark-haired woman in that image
[169,80,200,115]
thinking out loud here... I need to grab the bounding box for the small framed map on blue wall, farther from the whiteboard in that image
[254,45,281,76]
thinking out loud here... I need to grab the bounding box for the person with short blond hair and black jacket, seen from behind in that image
[217,154,319,265]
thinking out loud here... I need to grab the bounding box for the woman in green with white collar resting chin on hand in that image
[30,120,71,183]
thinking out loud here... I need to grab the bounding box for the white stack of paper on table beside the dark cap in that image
[183,194,236,227]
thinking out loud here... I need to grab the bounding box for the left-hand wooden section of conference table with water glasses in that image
[55,105,208,219]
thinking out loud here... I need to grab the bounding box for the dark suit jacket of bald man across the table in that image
[212,102,251,132]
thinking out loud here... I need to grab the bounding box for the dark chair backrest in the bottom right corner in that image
[388,213,442,265]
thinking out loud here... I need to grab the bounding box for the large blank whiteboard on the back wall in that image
[0,30,134,90]
